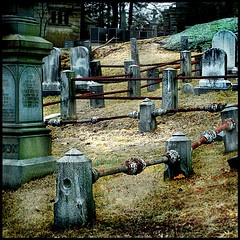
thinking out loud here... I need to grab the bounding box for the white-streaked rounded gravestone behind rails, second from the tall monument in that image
[70,46,90,92]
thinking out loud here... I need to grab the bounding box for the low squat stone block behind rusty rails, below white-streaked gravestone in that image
[88,81,105,108]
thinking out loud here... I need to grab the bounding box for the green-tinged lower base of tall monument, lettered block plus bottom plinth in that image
[2,122,56,189]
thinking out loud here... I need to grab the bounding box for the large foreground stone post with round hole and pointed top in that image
[54,149,95,228]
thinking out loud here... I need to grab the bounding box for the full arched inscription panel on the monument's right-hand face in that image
[19,67,42,122]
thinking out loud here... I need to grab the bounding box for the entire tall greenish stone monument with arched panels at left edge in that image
[2,1,56,188]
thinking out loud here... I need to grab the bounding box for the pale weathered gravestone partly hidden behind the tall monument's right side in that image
[42,47,61,96]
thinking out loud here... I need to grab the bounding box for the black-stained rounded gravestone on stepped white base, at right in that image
[194,48,231,94]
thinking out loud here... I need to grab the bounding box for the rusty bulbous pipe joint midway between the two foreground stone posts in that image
[124,158,147,175]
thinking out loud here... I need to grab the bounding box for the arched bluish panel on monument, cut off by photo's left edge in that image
[2,67,16,122]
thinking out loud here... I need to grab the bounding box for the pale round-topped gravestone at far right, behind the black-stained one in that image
[212,30,237,72]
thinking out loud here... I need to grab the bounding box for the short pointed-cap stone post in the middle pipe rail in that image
[138,98,157,132]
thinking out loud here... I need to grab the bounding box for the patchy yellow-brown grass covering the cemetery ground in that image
[2,38,238,238]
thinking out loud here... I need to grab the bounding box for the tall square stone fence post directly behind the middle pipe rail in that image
[162,68,178,110]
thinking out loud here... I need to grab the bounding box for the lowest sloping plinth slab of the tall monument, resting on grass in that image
[2,156,57,189]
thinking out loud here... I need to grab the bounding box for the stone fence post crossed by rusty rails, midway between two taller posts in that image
[128,65,141,97]
